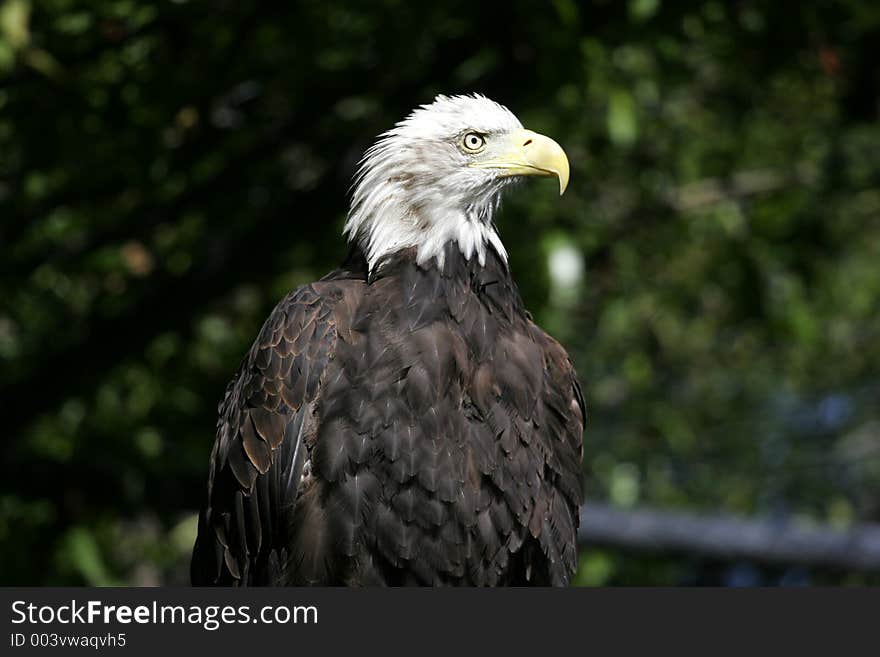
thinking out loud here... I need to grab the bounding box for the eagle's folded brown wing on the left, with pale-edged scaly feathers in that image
[191,282,354,585]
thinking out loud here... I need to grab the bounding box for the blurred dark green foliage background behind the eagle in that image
[0,0,880,585]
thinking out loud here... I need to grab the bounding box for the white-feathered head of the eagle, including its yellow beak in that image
[345,95,569,271]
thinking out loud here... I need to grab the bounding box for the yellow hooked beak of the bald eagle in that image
[470,130,568,196]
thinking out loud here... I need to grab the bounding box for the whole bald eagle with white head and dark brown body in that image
[191,95,585,586]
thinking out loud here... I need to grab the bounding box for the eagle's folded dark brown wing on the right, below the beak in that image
[488,322,585,586]
